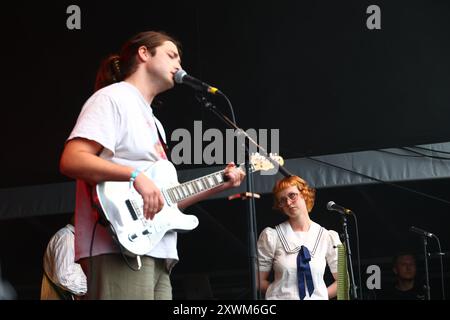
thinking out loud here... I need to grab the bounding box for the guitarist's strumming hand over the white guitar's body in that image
[134,173,164,220]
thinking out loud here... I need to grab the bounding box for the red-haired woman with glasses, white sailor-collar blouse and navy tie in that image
[258,176,341,300]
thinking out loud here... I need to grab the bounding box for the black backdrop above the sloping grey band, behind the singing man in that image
[0,0,450,187]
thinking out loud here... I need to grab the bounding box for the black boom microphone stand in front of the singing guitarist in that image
[196,93,292,300]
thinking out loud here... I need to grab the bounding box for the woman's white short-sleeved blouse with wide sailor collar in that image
[258,221,341,300]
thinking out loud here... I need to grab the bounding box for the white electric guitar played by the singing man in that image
[94,153,284,255]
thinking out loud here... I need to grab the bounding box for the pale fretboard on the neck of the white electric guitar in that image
[166,170,225,203]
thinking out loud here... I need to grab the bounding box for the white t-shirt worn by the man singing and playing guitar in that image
[68,82,178,262]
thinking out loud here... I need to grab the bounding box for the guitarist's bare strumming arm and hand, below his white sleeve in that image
[60,138,164,219]
